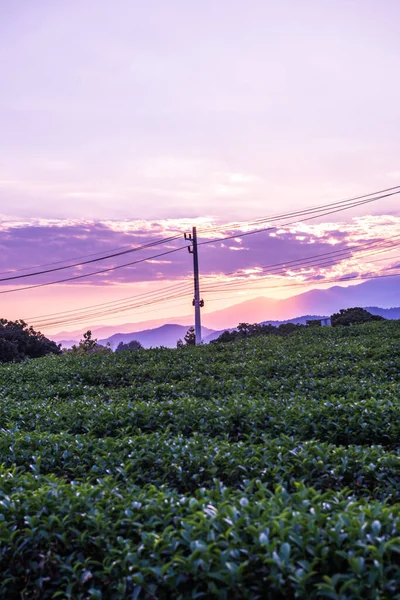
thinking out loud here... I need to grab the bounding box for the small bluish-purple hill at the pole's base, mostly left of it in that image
[99,324,214,350]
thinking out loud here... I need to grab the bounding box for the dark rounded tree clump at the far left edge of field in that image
[0,319,61,362]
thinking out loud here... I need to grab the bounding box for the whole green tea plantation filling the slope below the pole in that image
[0,322,400,600]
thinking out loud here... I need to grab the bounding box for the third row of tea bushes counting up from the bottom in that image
[2,394,400,448]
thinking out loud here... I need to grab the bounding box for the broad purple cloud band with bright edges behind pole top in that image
[0,215,400,289]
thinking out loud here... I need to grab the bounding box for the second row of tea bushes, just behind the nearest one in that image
[0,433,400,502]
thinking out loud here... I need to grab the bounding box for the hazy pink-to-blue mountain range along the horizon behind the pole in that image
[48,277,400,348]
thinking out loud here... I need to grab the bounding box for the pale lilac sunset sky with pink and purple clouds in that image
[0,0,400,331]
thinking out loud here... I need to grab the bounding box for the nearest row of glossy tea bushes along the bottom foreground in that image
[0,474,400,600]
